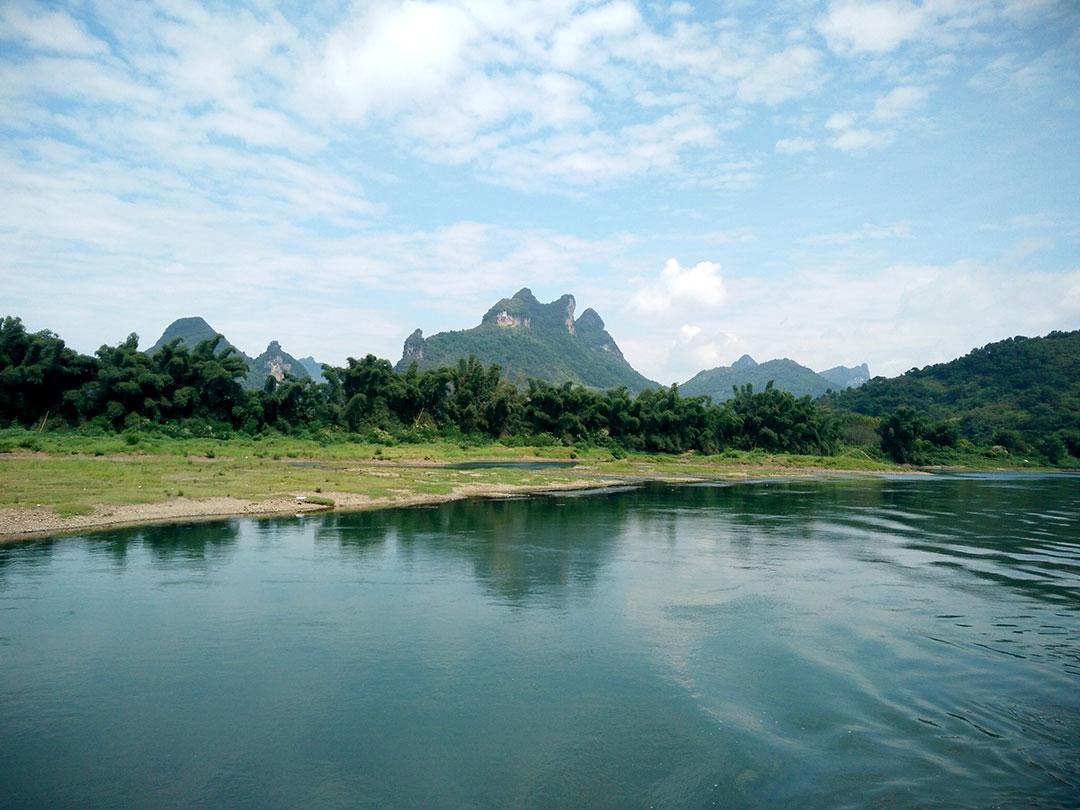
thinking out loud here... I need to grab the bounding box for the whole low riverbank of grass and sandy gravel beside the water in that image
[0,435,920,542]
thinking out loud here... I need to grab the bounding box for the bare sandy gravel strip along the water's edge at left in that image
[0,478,624,543]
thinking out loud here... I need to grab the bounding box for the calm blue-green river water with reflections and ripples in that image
[0,476,1080,808]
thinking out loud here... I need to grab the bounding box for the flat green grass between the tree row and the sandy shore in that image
[0,430,1054,515]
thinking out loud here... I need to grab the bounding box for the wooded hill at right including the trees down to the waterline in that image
[824,330,1080,463]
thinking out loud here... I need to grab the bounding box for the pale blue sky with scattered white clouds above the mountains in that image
[0,0,1080,383]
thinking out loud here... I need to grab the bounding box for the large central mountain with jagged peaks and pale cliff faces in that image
[396,288,658,393]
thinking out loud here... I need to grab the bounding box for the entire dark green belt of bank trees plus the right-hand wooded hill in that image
[0,318,1080,465]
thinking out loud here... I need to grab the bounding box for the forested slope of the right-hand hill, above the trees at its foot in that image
[826,330,1080,457]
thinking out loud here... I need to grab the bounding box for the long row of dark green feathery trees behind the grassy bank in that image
[0,318,838,455]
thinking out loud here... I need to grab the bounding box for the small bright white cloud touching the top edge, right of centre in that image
[818,0,927,54]
